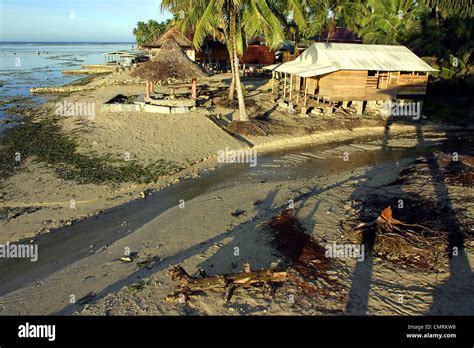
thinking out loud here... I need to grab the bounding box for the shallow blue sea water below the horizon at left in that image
[0,42,134,118]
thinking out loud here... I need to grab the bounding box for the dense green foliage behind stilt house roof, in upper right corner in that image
[340,0,474,79]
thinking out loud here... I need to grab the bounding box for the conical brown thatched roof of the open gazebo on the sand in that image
[131,39,207,81]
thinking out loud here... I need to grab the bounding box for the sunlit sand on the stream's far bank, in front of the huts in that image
[0,74,470,242]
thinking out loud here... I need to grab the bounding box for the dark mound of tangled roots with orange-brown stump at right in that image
[341,153,474,271]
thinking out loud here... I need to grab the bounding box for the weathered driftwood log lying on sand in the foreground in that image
[167,263,287,302]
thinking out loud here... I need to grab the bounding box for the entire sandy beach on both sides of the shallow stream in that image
[0,69,474,315]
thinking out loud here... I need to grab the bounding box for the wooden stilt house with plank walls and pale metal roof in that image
[265,43,436,113]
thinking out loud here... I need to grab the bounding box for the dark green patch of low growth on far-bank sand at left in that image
[0,116,182,184]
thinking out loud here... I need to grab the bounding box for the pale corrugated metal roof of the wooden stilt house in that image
[267,42,437,77]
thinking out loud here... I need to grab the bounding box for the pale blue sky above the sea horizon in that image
[0,0,171,42]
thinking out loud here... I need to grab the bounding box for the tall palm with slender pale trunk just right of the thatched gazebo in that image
[161,0,301,121]
